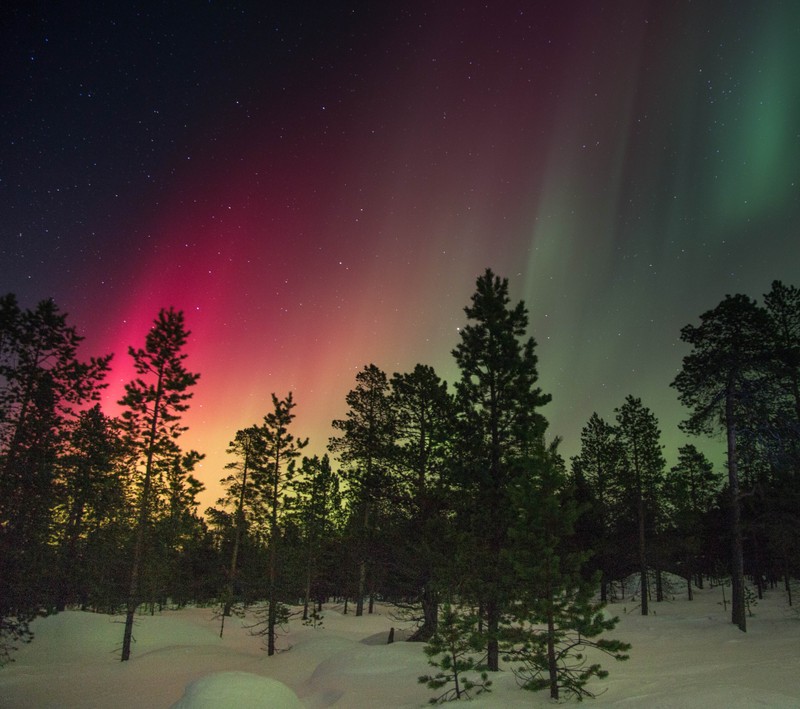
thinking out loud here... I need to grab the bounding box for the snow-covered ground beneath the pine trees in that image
[0,588,800,709]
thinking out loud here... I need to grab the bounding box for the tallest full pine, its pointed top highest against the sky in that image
[453,269,550,671]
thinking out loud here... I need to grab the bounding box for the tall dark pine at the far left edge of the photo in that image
[0,294,111,654]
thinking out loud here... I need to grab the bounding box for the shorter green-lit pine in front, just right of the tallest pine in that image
[504,441,630,700]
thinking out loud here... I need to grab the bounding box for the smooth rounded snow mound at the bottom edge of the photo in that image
[172,672,303,709]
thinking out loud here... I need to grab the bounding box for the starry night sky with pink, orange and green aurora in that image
[0,0,800,505]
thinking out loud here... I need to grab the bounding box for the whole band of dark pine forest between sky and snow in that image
[0,270,800,700]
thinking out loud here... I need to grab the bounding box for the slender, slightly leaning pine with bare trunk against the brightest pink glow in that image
[119,308,200,662]
